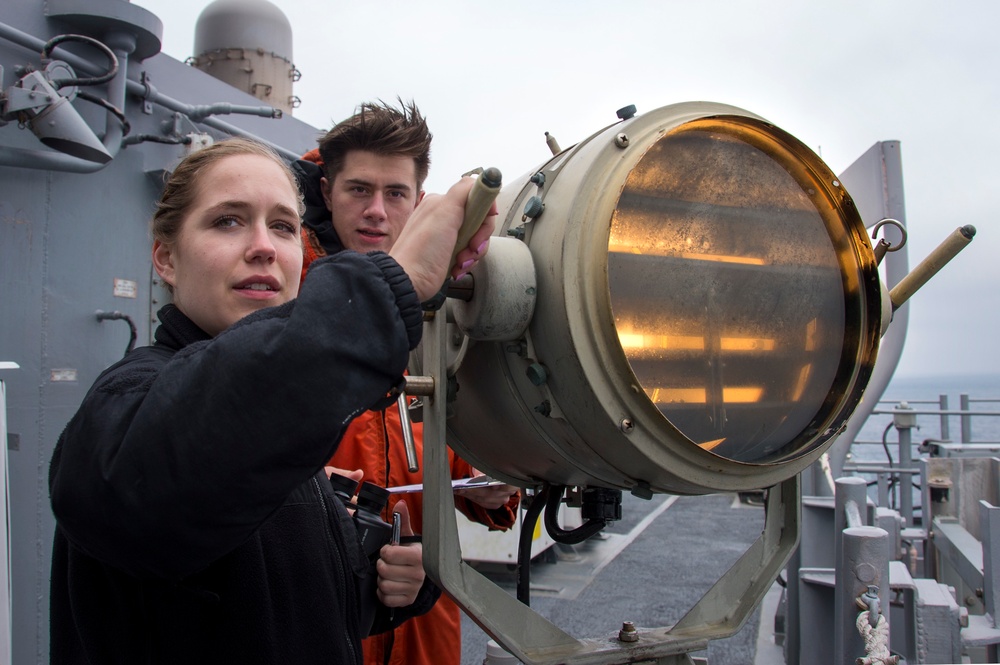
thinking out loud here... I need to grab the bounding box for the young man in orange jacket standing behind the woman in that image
[293,103,519,665]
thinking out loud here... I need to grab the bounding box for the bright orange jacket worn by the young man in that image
[330,405,519,665]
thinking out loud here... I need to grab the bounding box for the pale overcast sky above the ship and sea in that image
[135,0,1000,383]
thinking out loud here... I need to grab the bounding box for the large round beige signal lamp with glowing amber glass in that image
[447,103,885,494]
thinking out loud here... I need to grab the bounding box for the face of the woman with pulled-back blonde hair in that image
[153,155,302,336]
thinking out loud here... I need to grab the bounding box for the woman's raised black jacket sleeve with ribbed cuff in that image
[50,252,421,579]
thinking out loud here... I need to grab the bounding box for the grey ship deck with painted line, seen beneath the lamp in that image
[462,494,783,665]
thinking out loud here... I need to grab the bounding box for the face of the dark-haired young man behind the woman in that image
[322,150,422,253]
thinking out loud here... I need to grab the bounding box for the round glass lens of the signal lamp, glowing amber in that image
[608,120,858,463]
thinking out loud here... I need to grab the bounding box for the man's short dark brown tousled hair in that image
[319,100,432,191]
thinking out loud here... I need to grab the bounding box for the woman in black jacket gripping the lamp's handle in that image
[49,139,493,665]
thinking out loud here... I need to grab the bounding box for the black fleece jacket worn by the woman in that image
[49,252,440,665]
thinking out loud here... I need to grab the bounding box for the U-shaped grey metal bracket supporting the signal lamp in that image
[423,308,801,665]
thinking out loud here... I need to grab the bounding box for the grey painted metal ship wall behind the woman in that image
[0,0,317,664]
